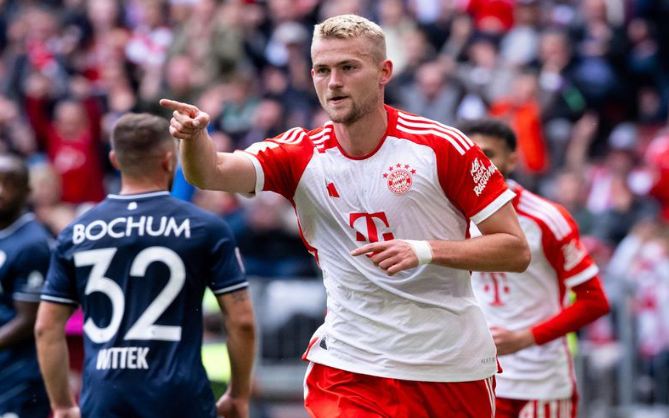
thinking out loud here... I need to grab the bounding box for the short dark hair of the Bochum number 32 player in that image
[111,113,175,175]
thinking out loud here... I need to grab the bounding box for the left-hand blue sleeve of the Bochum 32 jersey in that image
[42,240,79,305]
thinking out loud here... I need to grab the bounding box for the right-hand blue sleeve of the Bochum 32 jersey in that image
[208,220,248,295]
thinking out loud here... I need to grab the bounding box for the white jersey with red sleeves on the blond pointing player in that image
[245,107,514,382]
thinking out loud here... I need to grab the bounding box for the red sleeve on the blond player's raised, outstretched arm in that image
[239,128,314,199]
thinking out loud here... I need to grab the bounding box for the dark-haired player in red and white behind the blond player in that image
[460,119,609,418]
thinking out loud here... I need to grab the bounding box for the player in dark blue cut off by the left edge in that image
[0,155,50,418]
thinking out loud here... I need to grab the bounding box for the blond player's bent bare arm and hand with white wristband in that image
[351,203,531,275]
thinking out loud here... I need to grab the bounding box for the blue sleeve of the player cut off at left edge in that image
[12,240,49,303]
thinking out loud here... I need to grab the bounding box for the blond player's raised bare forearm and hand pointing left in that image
[160,99,256,193]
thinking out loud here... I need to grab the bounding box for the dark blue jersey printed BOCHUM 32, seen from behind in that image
[42,192,247,418]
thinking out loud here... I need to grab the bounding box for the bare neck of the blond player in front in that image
[334,105,388,157]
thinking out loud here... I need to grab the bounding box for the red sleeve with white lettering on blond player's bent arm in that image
[436,136,514,224]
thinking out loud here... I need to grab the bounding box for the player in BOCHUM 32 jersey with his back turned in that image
[35,114,255,418]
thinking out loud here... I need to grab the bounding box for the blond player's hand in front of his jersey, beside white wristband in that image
[351,239,418,276]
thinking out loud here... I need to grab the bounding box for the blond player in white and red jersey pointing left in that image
[161,15,529,418]
